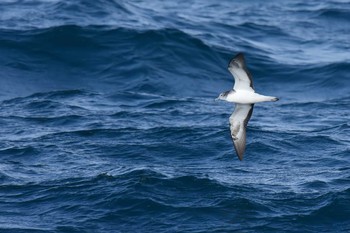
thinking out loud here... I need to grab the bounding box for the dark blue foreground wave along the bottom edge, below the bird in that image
[3,168,348,231]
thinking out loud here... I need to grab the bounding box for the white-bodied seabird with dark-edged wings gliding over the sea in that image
[217,53,278,160]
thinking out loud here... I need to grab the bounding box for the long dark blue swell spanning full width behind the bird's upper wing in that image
[2,24,348,100]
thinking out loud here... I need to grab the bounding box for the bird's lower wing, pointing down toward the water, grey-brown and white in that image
[230,104,254,160]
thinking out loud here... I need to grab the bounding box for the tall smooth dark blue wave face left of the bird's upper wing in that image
[3,26,227,98]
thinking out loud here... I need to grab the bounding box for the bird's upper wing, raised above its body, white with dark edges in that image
[228,53,254,92]
